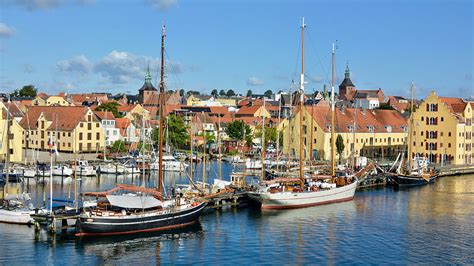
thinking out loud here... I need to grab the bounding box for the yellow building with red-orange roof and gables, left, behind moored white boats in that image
[20,106,105,152]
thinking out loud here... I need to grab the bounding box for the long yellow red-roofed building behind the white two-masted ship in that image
[283,106,408,160]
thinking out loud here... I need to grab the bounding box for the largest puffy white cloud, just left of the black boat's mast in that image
[94,50,159,84]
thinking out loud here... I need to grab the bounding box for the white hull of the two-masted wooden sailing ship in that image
[249,180,357,210]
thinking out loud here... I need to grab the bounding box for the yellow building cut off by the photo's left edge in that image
[0,102,23,163]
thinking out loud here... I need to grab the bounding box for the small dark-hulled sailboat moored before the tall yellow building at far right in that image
[388,82,438,187]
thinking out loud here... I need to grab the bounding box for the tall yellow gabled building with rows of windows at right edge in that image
[409,92,473,165]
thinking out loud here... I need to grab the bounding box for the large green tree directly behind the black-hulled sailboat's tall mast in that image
[151,114,189,148]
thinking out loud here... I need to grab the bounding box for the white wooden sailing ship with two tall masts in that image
[249,18,357,209]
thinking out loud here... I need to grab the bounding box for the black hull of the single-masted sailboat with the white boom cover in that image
[76,202,207,236]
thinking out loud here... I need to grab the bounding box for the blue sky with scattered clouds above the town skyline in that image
[0,0,474,97]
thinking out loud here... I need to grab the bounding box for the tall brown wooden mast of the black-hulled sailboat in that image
[158,23,166,193]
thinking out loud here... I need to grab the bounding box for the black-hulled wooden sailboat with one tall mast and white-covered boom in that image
[76,26,207,236]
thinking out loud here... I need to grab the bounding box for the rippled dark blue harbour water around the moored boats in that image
[0,164,474,265]
